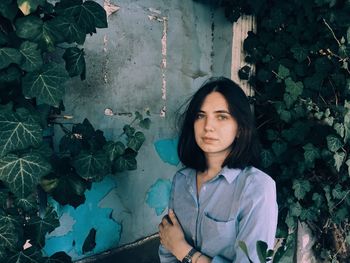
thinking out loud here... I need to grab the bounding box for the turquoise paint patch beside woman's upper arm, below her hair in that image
[146,179,171,216]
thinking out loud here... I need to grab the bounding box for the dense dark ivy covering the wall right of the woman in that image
[216,0,350,262]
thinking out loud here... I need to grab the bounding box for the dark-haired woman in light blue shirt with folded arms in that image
[159,77,278,263]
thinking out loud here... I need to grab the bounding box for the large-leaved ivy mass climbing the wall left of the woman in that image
[0,0,150,262]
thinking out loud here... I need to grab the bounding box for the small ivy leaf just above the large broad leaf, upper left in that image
[19,41,43,72]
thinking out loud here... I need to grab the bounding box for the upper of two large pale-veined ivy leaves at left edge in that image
[0,111,42,157]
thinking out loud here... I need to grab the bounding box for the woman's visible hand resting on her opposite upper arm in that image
[159,209,192,261]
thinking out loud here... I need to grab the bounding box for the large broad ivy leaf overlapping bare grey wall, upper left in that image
[22,63,68,107]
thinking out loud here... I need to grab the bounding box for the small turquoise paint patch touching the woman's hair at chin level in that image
[154,138,180,166]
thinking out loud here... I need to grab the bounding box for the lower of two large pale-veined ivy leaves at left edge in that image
[0,153,51,198]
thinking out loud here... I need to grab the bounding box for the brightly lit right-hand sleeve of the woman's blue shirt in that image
[234,175,278,263]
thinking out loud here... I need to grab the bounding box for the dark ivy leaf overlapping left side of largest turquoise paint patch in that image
[25,207,60,248]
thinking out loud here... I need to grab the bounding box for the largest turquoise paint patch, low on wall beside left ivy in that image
[43,176,122,260]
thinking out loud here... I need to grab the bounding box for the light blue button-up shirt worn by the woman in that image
[159,167,278,263]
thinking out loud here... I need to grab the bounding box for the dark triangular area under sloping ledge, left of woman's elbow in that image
[75,234,159,263]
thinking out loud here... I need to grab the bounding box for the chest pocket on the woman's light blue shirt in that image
[201,213,237,258]
